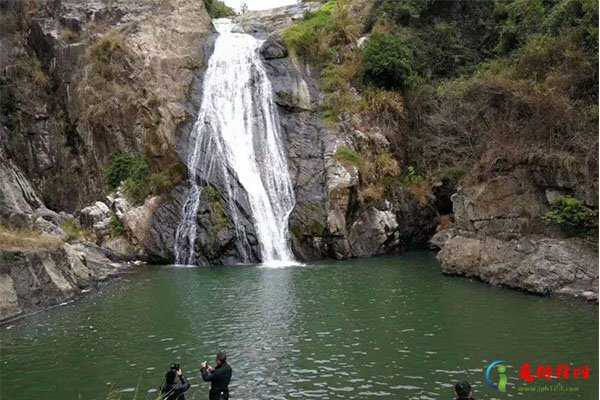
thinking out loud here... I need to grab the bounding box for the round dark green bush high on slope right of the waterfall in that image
[360,33,415,90]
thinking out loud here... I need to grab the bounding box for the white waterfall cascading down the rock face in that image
[175,19,295,264]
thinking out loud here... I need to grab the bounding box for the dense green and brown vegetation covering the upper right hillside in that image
[283,0,598,212]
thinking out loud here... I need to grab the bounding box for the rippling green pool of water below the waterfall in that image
[0,253,598,400]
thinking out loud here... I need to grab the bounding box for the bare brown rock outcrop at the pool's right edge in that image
[430,169,598,301]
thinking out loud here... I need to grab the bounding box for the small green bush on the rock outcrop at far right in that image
[543,197,598,235]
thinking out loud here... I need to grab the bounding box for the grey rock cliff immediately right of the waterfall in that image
[238,3,435,260]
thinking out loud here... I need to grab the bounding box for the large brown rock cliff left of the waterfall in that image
[0,0,212,319]
